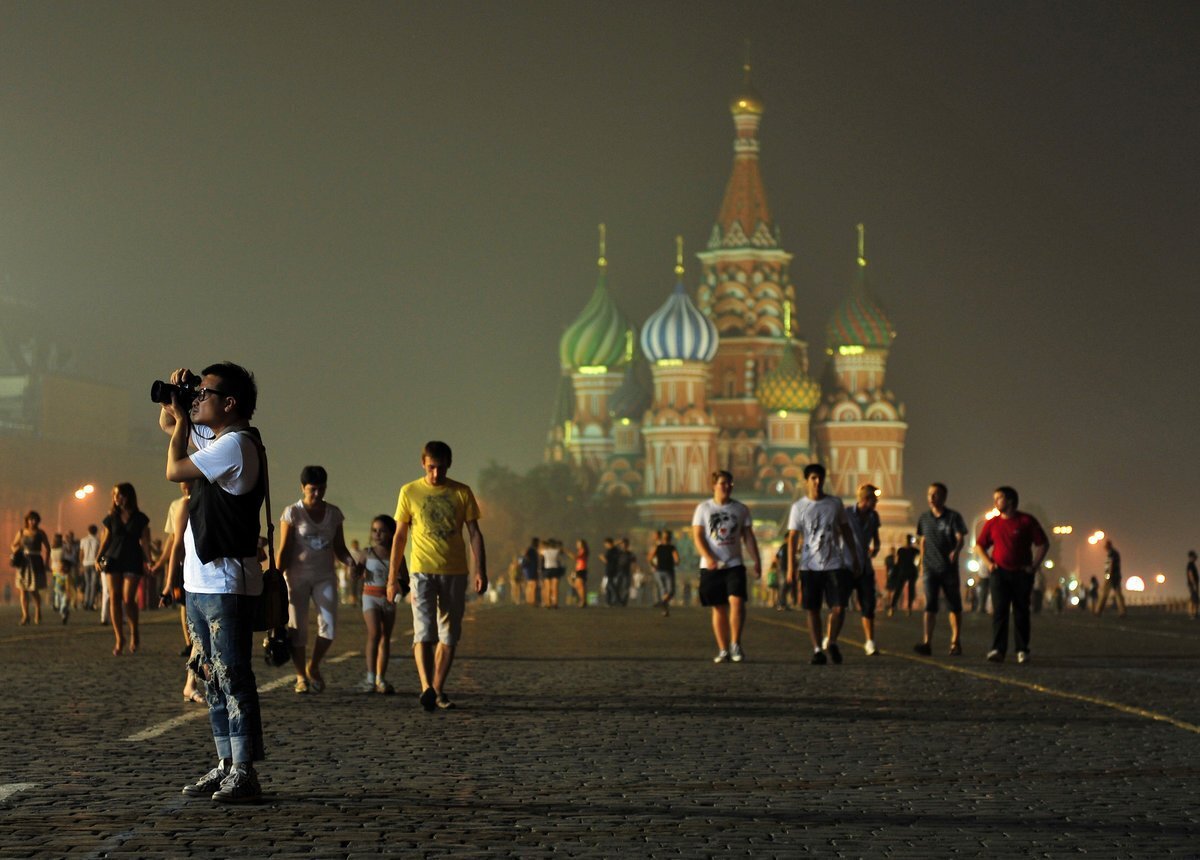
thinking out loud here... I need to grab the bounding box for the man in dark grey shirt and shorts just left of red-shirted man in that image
[914,481,967,657]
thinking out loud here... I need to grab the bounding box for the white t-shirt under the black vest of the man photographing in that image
[184,428,263,596]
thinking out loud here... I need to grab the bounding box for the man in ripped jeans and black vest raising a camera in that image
[159,362,266,804]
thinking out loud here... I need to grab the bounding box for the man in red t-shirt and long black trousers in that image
[976,487,1050,663]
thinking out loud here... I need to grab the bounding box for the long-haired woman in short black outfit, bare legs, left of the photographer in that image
[100,483,150,657]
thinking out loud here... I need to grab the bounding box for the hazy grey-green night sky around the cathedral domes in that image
[0,0,1200,577]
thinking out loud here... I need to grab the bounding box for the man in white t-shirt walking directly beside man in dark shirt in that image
[787,463,863,666]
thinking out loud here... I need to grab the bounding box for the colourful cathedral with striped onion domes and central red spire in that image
[546,66,913,558]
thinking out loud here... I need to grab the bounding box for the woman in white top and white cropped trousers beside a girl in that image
[280,465,354,693]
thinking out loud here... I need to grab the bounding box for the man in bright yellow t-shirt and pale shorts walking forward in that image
[388,441,487,711]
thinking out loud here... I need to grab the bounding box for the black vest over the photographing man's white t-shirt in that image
[187,427,266,564]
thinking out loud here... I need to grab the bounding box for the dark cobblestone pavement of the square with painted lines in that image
[0,597,1200,858]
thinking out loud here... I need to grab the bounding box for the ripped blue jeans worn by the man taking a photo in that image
[187,591,263,764]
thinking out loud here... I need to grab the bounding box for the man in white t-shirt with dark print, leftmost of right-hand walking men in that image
[691,470,762,663]
